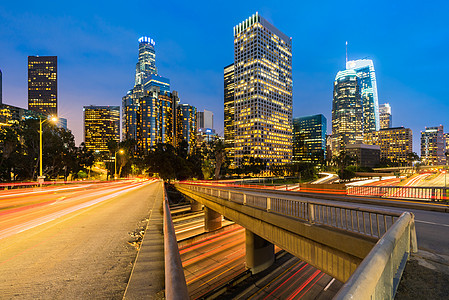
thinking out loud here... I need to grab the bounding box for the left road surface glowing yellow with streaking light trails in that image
[0,181,162,299]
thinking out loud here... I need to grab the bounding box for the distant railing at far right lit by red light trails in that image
[347,186,449,201]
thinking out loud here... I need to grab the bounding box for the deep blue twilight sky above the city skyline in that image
[0,0,449,154]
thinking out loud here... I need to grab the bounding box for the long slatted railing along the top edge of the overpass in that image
[181,183,400,238]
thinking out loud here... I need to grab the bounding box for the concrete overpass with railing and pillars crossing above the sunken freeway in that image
[176,183,417,299]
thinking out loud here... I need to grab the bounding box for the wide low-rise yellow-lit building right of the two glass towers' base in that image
[368,127,413,166]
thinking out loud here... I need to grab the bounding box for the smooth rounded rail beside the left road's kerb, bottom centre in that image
[163,189,189,300]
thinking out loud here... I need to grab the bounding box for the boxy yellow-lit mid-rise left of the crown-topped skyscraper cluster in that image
[83,105,120,152]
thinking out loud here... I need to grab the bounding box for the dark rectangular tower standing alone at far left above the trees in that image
[28,56,58,116]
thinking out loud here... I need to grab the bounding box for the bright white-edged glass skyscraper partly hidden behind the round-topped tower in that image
[346,59,380,133]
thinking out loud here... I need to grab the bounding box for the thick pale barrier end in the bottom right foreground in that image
[334,212,418,300]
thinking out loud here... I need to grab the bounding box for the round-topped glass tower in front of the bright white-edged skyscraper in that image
[332,70,363,155]
